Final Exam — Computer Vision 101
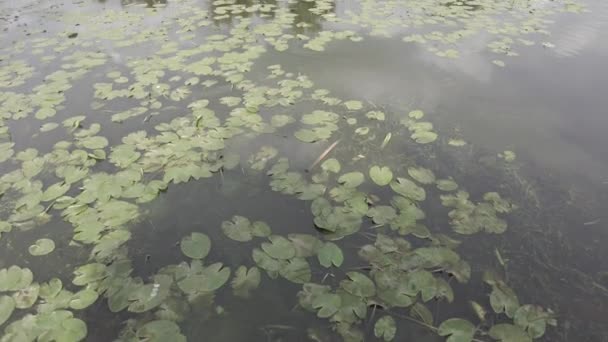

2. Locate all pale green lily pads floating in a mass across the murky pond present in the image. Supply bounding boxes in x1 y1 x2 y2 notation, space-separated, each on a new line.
0 0 581 342
